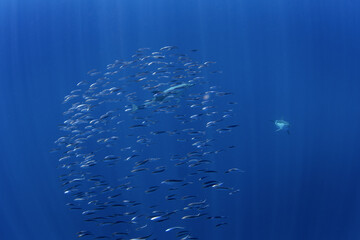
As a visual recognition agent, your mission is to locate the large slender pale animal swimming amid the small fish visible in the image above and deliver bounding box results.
[132,83,194,111]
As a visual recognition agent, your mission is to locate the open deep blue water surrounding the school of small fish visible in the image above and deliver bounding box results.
[0,0,360,240]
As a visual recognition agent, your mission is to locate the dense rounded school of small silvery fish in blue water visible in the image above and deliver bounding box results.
[54,46,243,240]
